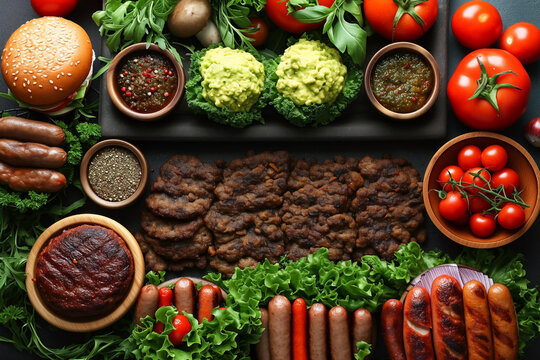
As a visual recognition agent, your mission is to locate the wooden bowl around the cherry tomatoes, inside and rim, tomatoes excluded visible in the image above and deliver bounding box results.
[423,132,540,248]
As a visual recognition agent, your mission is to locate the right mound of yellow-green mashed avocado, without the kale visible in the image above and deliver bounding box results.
[276,39,347,106]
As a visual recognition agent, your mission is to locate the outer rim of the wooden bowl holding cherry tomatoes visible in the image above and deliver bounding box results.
[422,131,540,249]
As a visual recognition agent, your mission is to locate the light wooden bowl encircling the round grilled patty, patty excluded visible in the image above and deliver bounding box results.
[26,214,145,332]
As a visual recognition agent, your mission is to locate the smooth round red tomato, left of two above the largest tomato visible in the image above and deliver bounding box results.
[452,0,502,49]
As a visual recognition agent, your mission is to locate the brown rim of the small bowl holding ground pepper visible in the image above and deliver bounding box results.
[80,139,148,209]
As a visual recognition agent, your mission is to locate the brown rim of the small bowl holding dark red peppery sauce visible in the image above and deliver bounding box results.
[107,43,186,121]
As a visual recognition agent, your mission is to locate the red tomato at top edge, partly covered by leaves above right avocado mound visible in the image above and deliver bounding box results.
[264,0,334,34]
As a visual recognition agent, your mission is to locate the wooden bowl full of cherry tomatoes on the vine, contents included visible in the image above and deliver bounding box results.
[423,132,540,248]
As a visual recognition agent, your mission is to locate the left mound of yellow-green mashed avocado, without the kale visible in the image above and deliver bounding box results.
[200,47,264,112]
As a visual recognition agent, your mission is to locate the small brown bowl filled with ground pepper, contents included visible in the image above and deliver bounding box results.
[80,139,148,209]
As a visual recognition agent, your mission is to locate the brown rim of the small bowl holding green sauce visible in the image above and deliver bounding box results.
[364,42,441,120]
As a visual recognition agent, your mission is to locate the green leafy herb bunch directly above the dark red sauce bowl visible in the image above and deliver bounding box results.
[92,0,182,64]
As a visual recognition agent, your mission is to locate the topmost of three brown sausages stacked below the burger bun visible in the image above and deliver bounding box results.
[0,116,66,146]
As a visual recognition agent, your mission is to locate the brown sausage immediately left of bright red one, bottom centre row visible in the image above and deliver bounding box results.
[268,295,291,360]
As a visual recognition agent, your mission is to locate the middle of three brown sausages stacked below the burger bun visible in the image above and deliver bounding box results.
[0,139,67,169]
